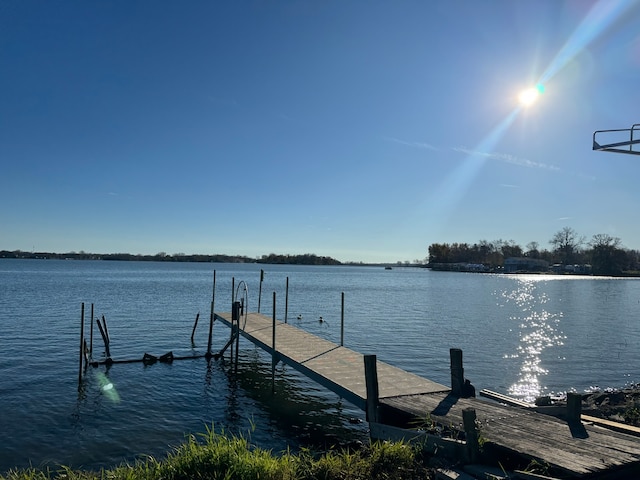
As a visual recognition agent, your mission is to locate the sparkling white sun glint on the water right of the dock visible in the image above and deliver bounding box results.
[496,277,566,402]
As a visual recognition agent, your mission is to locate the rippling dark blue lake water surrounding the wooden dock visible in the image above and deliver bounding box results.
[0,259,640,472]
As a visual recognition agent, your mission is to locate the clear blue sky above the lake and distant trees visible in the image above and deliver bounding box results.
[0,0,640,262]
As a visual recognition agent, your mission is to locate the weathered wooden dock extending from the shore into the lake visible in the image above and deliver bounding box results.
[214,313,640,478]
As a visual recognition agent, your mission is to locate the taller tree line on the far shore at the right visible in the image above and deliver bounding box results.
[428,227,640,276]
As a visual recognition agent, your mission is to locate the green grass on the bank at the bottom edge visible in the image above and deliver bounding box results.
[0,428,431,480]
